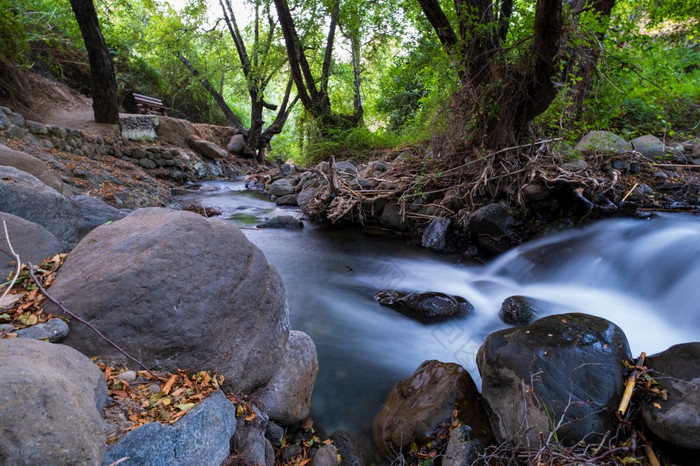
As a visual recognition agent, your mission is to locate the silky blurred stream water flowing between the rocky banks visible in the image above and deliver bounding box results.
[174,181,700,452]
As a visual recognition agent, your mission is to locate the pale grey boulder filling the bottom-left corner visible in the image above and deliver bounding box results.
[0,338,107,465]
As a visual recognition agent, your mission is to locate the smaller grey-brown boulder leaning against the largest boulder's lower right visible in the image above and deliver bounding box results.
[256,330,318,425]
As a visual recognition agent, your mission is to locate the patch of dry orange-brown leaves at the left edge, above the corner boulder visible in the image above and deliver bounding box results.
[0,254,67,337]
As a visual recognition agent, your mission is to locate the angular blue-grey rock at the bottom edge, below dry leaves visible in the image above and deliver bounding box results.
[104,391,236,466]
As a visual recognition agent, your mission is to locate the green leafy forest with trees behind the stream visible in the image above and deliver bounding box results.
[0,0,700,163]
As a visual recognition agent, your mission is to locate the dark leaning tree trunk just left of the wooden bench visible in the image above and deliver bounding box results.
[70,0,119,124]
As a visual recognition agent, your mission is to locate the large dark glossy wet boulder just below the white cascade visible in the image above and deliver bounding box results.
[477,313,631,448]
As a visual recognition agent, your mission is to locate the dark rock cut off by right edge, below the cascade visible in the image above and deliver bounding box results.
[642,342,700,450]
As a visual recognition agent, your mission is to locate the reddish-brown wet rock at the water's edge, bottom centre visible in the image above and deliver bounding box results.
[372,360,491,453]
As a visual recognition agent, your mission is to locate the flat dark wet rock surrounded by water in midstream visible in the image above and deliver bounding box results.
[374,290,474,322]
